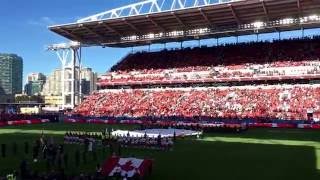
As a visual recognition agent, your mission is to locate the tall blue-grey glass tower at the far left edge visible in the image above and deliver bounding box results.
[0,54,23,102]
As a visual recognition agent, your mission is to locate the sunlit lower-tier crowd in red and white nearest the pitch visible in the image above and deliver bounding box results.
[74,85,320,120]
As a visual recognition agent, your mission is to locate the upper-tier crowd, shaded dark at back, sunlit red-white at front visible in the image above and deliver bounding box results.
[99,38,320,86]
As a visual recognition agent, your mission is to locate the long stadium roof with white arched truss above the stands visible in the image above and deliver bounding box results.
[49,0,320,47]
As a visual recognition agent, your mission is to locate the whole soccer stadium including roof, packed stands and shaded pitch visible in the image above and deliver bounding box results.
[0,0,320,180]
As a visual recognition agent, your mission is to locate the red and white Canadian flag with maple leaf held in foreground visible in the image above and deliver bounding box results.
[102,157,152,177]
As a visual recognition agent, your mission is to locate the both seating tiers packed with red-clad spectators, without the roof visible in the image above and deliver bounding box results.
[74,37,320,120]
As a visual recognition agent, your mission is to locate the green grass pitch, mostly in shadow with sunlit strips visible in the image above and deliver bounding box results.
[0,123,320,180]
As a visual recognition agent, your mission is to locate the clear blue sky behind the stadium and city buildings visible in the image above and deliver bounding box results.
[0,0,317,84]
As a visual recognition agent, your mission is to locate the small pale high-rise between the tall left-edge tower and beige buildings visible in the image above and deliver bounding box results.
[24,73,46,96]
